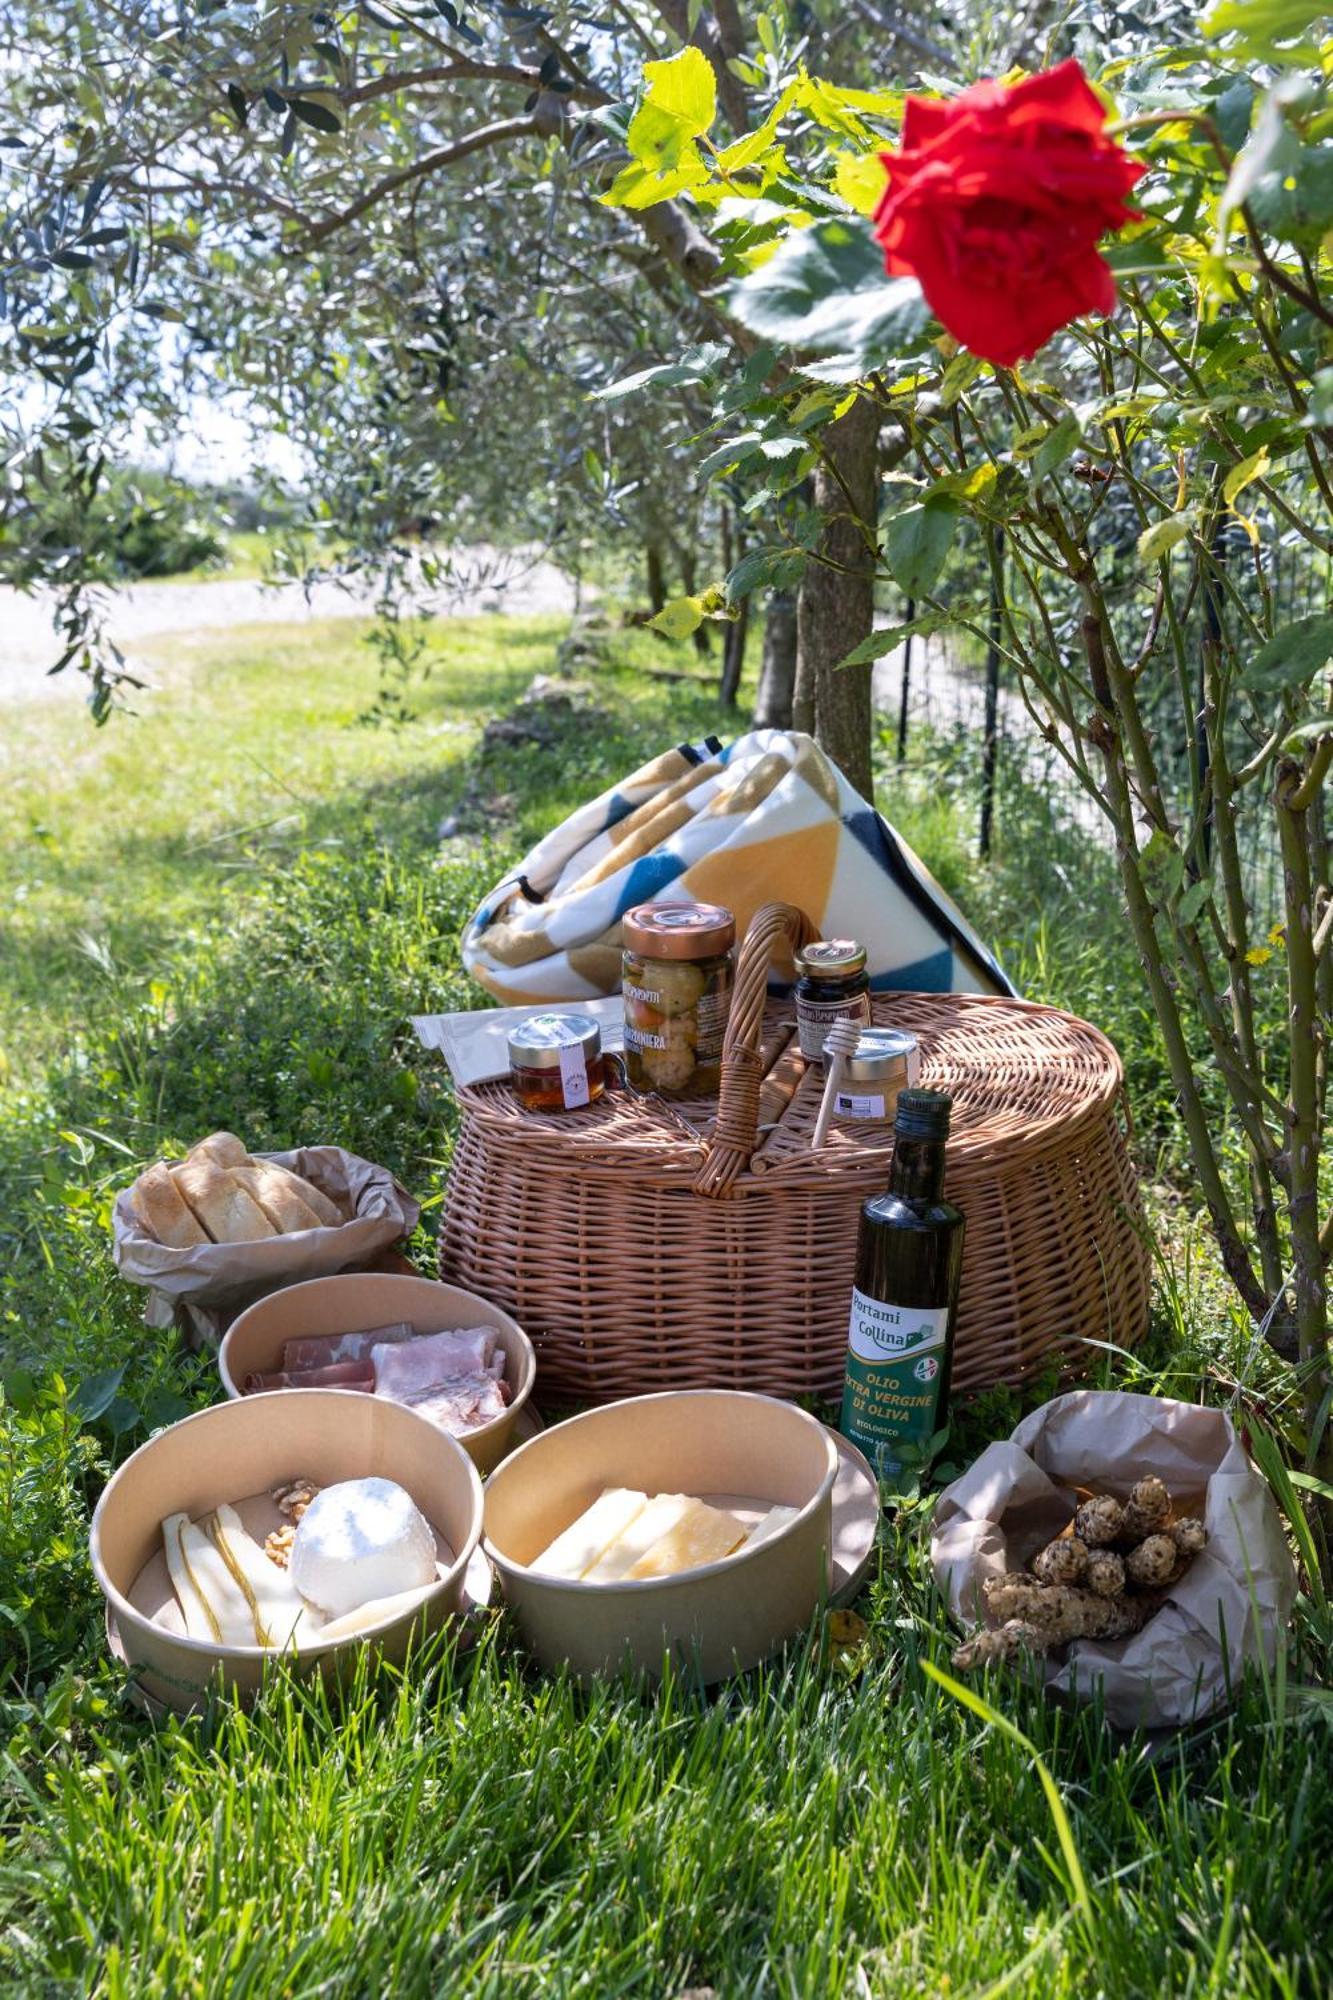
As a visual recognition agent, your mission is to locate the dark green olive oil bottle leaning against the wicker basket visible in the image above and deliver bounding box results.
[841,1090,963,1484]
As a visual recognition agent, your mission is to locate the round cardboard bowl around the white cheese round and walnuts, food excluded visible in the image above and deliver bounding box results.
[90,1388,482,1712]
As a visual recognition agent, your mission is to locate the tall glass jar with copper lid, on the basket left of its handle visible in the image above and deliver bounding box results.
[620,902,737,1098]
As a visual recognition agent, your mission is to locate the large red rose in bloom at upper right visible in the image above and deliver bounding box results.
[875,62,1143,368]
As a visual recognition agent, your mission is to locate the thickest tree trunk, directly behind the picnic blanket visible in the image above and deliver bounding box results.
[795,396,879,798]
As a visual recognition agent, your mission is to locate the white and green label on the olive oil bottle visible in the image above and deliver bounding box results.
[839,1292,949,1480]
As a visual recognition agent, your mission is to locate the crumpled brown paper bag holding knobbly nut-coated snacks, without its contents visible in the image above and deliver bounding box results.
[931,1390,1295,1730]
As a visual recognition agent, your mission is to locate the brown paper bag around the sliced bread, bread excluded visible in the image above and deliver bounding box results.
[112,1146,420,1348]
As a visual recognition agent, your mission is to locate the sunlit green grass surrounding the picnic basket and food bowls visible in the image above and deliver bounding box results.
[0,620,1333,2000]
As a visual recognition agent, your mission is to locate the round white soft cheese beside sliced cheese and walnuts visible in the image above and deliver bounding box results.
[288,1480,436,1618]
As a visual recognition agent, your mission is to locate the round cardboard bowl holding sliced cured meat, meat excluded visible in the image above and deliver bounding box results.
[218,1274,536,1474]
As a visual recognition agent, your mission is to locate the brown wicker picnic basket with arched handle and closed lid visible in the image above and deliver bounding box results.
[440,904,1149,1402]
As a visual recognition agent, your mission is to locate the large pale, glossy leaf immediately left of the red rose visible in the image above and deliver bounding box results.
[729,222,931,382]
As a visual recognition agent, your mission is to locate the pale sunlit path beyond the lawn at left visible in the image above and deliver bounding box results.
[0,550,574,704]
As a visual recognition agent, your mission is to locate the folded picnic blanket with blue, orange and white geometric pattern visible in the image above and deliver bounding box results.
[462,730,1013,1006]
